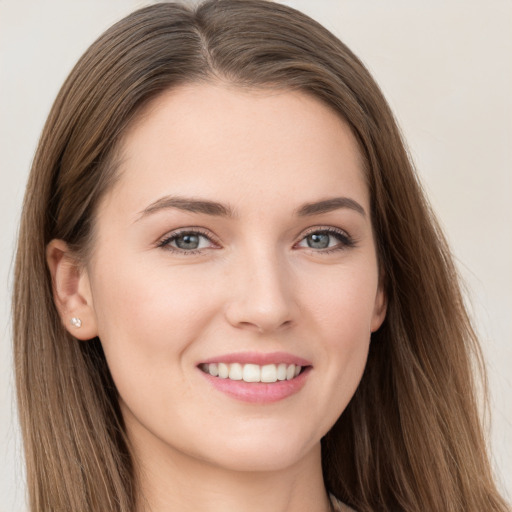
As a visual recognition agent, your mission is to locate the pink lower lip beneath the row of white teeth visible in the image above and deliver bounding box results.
[199,367,311,404]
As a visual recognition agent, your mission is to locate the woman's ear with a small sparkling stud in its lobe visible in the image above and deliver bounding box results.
[46,240,98,340]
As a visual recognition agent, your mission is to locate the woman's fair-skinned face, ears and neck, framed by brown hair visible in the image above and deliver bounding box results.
[47,84,385,512]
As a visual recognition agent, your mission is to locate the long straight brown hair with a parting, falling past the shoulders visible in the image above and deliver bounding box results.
[13,0,507,512]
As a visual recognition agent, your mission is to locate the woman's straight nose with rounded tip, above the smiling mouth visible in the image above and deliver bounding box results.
[225,249,298,334]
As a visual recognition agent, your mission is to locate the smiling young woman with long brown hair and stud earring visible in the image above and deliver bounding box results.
[14,0,506,511]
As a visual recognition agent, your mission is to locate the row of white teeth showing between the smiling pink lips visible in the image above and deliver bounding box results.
[199,363,308,383]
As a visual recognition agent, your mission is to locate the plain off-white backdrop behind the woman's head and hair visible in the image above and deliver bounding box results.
[0,0,512,512]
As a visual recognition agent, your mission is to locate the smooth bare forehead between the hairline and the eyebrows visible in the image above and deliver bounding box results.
[105,83,368,218]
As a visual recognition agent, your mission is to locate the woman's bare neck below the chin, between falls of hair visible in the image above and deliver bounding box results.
[137,434,330,512]
